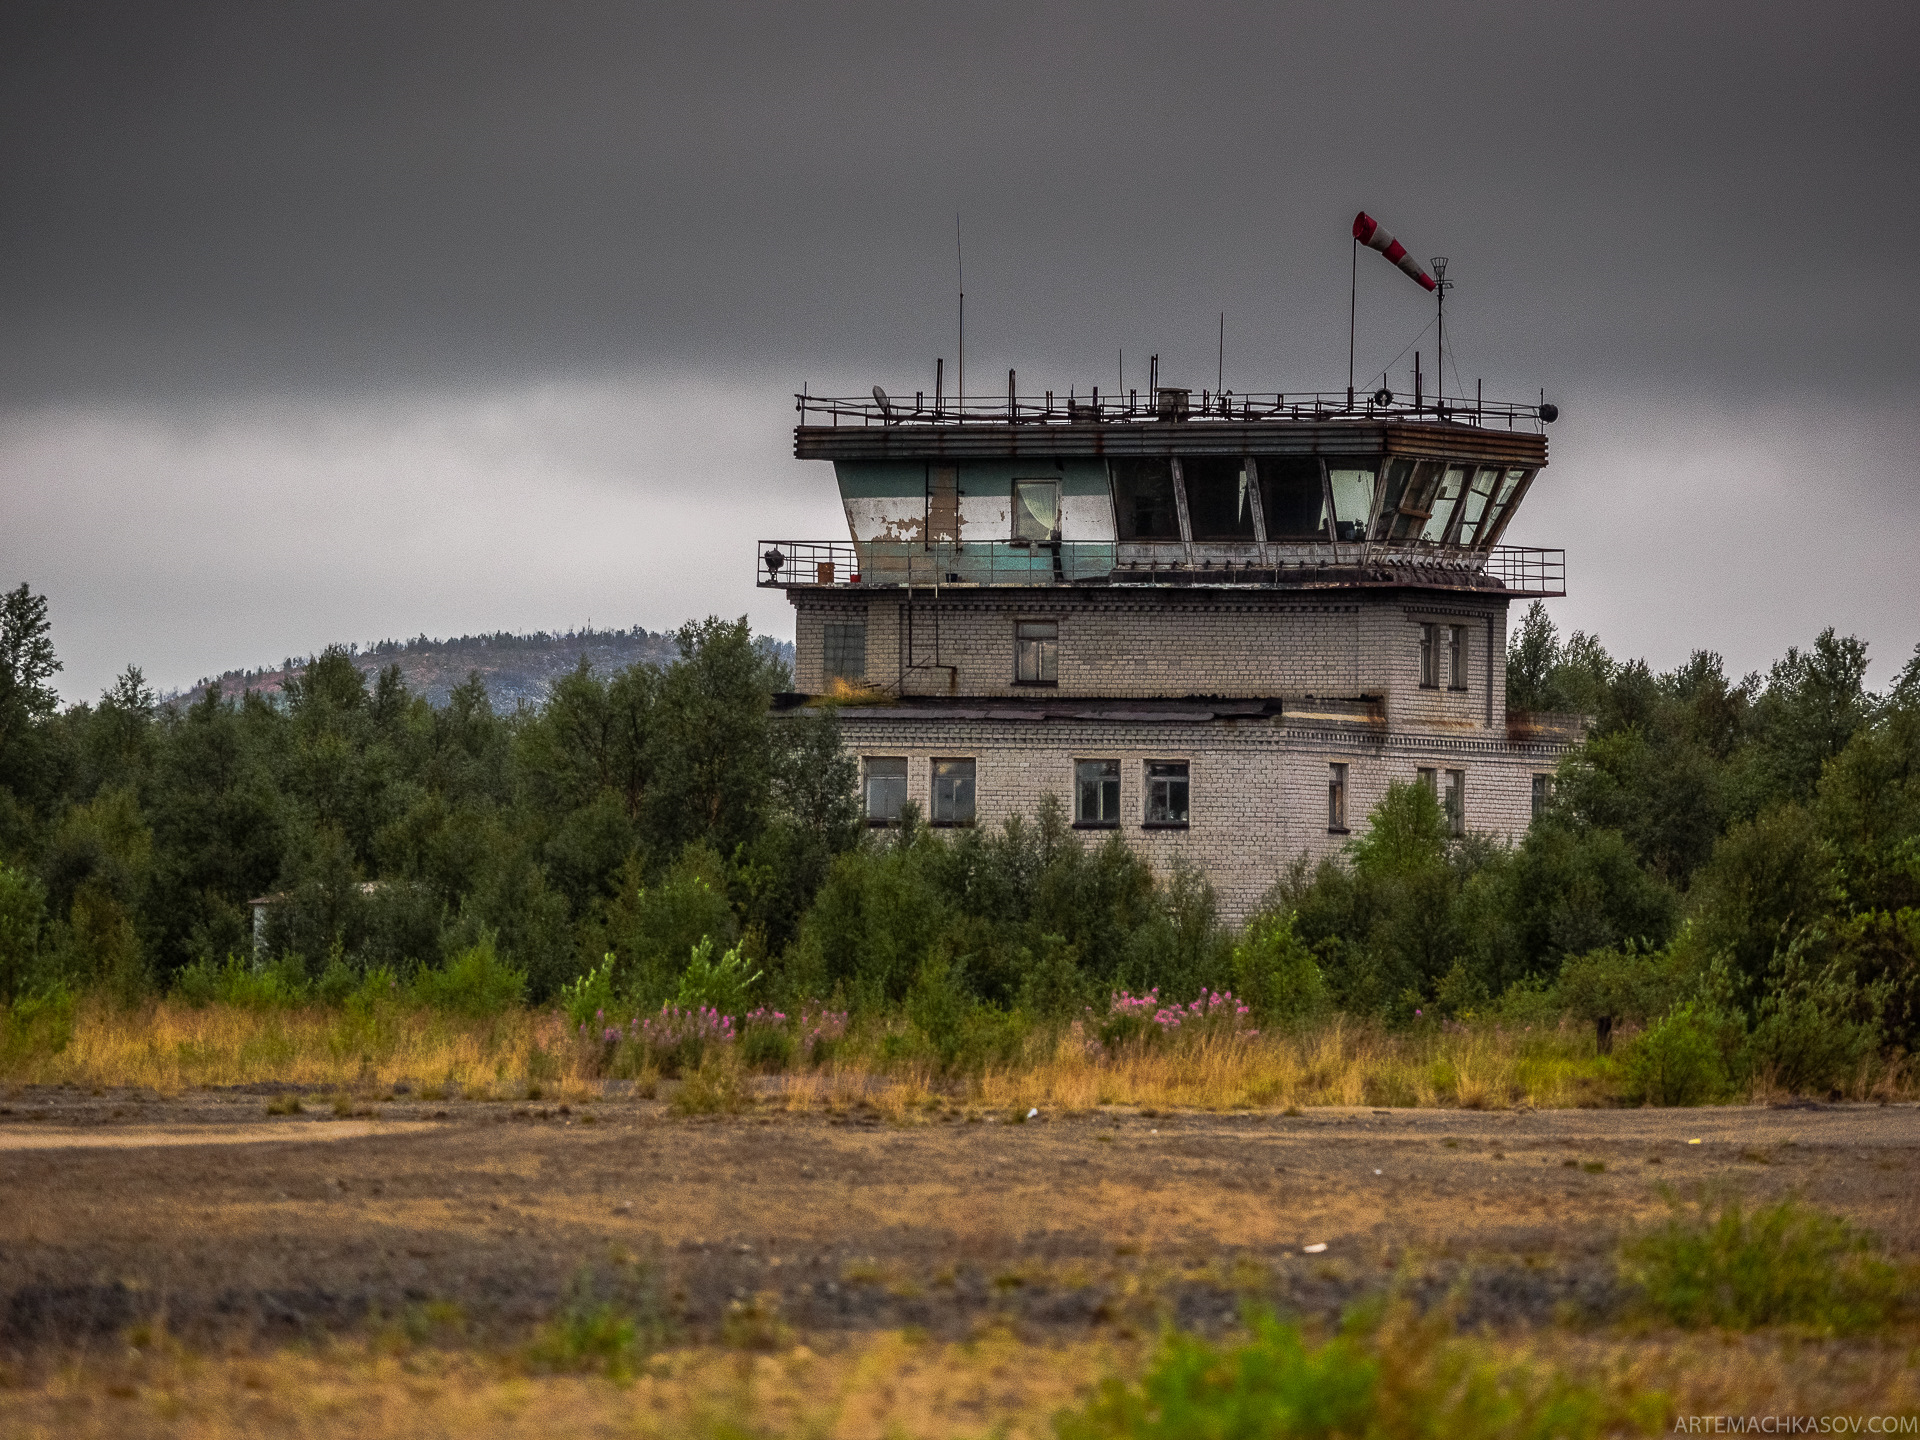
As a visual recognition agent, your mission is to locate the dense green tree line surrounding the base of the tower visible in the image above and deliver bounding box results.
[0,586,1920,1090]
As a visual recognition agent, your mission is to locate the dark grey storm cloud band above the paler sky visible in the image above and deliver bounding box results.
[0,2,1920,401]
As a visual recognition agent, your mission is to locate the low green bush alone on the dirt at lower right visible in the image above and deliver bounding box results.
[1622,1200,1901,1334]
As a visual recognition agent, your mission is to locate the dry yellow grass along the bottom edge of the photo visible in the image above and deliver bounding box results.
[0,1329,1920,1440]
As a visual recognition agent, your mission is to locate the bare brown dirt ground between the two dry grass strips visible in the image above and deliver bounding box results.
[0,1089,1920,1359]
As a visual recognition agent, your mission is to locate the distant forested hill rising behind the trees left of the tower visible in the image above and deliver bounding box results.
[167,626,793,710]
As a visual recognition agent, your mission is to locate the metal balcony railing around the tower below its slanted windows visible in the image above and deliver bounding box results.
[758,540,1567,597]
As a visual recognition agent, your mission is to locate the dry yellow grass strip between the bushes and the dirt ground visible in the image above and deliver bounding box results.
[0,1000,1916,1119]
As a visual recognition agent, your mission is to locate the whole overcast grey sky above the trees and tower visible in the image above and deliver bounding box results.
[0,0,1920,699]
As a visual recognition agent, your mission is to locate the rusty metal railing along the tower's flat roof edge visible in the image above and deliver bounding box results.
[793,386,1559,430]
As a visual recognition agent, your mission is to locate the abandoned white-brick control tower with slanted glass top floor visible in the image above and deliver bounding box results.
[758,360,1571,922]
